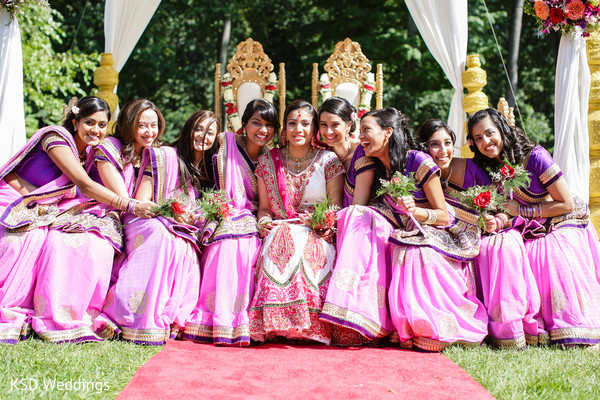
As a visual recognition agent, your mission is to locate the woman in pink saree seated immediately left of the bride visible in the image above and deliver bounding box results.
[183,99,279,346]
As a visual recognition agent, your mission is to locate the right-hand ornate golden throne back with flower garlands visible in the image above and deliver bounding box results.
[312,38,383,117]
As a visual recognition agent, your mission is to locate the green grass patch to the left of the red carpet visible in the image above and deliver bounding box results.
[0,339,162,399]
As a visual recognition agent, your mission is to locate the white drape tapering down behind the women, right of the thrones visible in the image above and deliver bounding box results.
[405,0,468,156]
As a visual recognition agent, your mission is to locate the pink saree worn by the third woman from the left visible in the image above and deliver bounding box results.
[100,146,200,345]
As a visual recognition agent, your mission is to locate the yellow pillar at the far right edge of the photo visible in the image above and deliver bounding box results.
[586,32,600,238]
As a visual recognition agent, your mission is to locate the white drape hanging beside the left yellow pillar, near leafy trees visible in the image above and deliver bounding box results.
[104,0,160,72]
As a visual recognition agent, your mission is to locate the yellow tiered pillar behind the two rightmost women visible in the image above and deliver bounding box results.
[461,54,488,157]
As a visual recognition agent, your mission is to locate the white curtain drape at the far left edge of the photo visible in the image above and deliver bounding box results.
[0,8,26,166]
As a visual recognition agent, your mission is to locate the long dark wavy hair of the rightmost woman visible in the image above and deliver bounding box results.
[467,108,535,169]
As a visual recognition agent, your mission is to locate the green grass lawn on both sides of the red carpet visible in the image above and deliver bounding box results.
[0,339,600,400]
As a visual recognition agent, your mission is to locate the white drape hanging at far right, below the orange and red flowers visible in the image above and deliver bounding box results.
[554,33,591,203]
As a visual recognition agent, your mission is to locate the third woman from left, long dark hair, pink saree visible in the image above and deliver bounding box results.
[98,111,219,345]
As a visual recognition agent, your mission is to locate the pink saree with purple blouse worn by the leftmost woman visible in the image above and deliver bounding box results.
[0,126,78,344]
